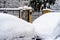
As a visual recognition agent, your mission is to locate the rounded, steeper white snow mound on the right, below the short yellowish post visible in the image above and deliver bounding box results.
[33,12,60,40]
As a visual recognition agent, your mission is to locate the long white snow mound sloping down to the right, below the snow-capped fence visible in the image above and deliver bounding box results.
[0,13,34,40]
